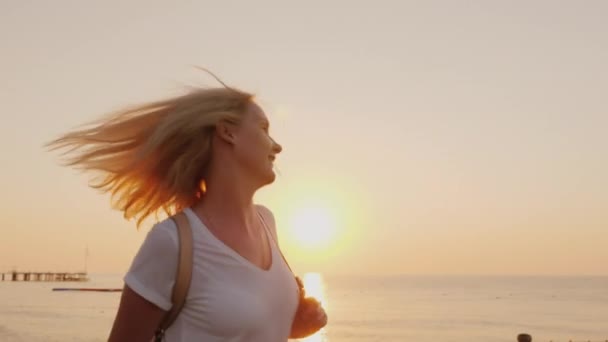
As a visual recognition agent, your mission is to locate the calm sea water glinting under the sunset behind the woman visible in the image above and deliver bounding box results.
[0,274,608,342]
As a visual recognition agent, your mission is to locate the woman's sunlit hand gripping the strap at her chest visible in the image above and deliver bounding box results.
[289,297,327,338]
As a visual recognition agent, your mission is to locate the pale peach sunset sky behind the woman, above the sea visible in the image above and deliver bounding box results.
[0,0,608,275]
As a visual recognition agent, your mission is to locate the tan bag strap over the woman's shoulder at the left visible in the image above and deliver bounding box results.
[154,212,193,341]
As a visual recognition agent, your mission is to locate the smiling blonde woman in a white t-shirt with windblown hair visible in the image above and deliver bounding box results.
[49,73,327,342]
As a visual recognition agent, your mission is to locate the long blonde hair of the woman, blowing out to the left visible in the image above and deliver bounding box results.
[46,83,253,227]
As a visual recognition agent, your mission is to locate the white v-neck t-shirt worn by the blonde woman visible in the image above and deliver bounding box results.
[124,208,298,342]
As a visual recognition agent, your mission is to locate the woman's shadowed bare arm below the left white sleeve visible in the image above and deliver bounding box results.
[108,285,166,342]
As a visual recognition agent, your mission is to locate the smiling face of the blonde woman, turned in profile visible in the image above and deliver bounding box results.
[234,102,282,185]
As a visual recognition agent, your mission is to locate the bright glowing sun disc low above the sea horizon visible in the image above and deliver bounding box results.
[289,207,337,248]
